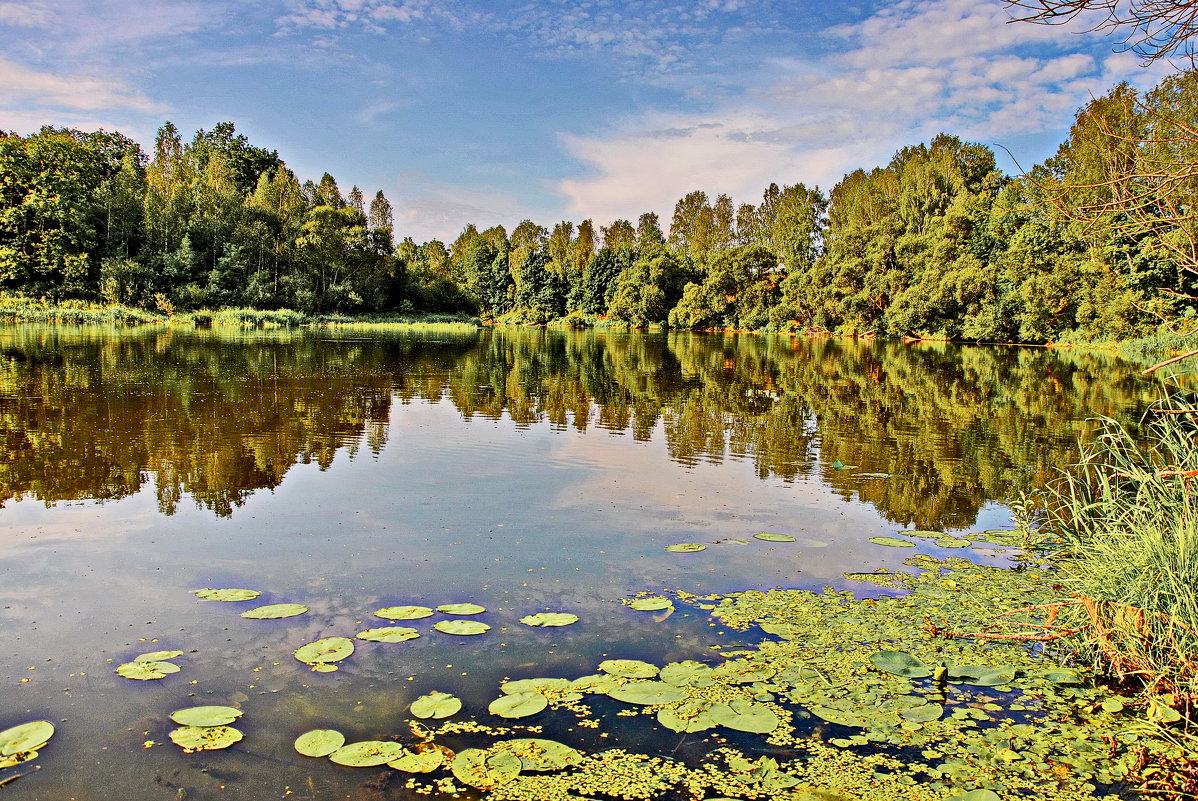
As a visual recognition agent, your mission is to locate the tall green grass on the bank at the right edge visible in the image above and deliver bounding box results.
[1048,393,1198,704]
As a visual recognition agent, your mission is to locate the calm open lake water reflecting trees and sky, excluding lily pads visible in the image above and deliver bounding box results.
[0,327,1154,801]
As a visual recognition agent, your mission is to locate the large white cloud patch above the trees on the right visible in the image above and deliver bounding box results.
[557,0,1155,227]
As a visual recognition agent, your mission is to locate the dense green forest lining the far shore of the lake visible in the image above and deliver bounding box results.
[0,71,1198,342]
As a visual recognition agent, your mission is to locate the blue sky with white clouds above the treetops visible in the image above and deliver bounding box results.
[0,0,1168,241]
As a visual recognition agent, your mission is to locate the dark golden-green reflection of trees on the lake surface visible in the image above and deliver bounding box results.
[0,328,1149,527]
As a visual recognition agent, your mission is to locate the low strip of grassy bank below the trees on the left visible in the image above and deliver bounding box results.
[0,296,478,332]
